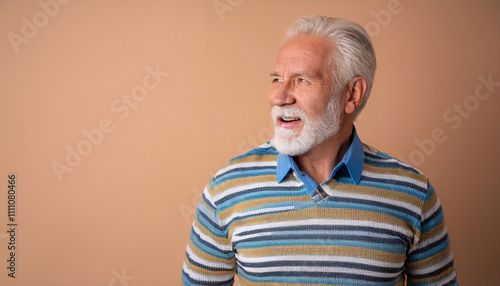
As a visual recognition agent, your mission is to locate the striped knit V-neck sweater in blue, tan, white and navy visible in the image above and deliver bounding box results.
[182,143,458,286]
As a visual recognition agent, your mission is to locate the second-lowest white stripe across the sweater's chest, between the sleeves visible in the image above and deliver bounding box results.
[233,219,414,241]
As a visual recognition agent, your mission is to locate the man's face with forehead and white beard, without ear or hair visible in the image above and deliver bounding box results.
[269,36,343,156]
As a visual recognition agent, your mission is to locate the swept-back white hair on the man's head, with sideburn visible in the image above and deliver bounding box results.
[285,15,377,119]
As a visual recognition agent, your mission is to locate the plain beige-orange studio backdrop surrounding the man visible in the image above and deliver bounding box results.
[0,0,500,286]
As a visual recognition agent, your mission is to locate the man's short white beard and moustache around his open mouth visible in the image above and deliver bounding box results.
[271,95,343,156]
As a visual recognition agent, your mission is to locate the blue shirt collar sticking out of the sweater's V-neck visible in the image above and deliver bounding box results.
[276,127,365,185]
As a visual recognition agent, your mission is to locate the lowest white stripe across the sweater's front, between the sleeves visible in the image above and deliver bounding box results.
[236,254,404,268]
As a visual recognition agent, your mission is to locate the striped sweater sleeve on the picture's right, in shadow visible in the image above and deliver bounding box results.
[405,182,458,286]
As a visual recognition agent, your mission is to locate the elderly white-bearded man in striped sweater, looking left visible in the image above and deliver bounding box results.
[182,16,458,285]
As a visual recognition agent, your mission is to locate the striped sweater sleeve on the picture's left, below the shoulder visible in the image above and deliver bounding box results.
[182,181,236,286]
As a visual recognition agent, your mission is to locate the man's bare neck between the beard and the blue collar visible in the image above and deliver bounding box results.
[293,123,353,184]
